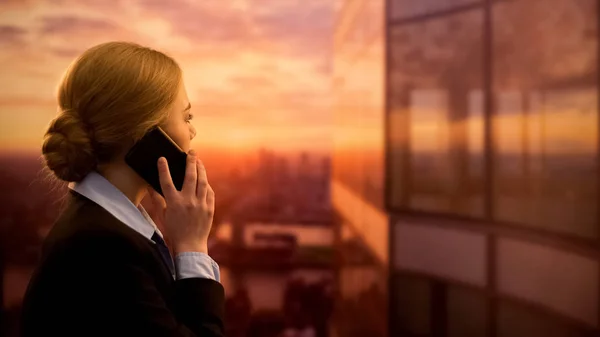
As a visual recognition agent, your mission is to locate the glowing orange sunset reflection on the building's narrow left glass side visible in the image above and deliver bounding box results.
[334,0,385,209]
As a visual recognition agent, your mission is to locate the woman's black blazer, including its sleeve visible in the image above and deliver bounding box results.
[21,191,225,337]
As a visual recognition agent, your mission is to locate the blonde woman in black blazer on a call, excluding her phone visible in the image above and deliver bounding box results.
[22,42,224,337]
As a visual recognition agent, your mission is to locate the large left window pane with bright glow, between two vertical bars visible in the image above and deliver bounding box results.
[389,9,483,217]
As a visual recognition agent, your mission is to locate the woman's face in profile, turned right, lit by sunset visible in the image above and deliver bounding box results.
[162,83,196,152]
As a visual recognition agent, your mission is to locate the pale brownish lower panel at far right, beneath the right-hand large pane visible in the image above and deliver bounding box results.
[497,238,599,325]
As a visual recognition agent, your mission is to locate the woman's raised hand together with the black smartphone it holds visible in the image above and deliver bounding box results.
[125,127,215,254]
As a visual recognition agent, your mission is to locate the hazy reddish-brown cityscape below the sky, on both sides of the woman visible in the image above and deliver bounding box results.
[0,149,333,337]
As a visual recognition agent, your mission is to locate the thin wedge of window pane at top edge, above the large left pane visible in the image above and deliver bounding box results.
[389,0,482,19]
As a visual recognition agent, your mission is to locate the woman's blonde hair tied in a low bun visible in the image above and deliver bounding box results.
[42,42,182,182]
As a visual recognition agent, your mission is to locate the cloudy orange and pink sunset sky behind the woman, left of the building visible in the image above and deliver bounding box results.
[0,0,337,150]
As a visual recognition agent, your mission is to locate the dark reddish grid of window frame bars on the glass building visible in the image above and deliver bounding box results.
[384,0,600,336]
